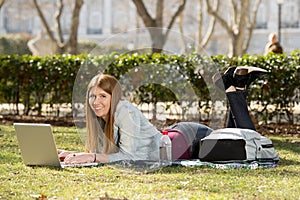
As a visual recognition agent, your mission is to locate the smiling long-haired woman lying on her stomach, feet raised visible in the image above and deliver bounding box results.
[58,67,266,164]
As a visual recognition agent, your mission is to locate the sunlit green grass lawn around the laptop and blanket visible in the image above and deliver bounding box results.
[0,125,300,200]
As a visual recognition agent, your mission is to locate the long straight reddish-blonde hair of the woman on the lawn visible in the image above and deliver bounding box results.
[85,74,122,154]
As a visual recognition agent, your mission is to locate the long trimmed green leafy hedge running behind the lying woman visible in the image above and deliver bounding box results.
[0,51,300,123]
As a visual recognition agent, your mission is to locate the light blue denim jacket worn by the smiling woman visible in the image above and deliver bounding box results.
[109,100,161,162]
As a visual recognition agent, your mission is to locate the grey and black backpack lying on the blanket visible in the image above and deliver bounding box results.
[199,128,279,163]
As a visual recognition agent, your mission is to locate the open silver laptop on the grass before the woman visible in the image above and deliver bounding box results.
[14,123,98,168]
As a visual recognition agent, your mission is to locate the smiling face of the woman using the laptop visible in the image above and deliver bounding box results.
[89,87,111,121]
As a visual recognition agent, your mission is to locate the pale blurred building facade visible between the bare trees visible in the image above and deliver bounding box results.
[0,0,300,54]
